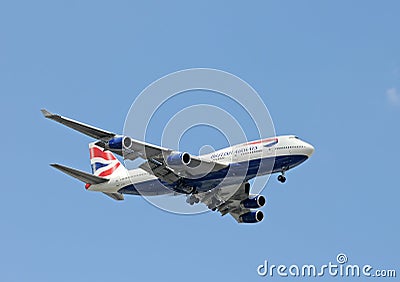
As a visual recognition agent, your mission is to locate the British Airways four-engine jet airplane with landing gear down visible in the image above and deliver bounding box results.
[41,109,314,223]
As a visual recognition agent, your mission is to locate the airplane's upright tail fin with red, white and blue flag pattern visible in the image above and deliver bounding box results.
[89,142,126,177]
